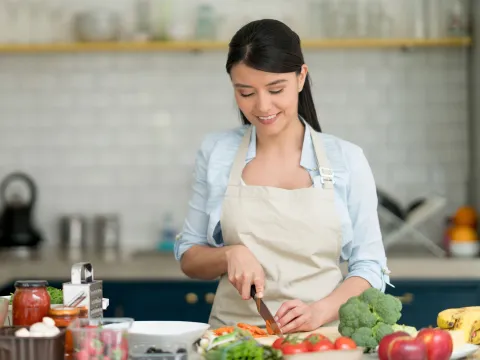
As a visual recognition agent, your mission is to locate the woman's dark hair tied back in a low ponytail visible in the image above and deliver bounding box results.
[226,19,322,132]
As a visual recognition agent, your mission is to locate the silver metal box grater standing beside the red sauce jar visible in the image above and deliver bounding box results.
[63,262,103,319]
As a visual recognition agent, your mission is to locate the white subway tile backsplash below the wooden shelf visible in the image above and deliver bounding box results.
[0,45,468,246]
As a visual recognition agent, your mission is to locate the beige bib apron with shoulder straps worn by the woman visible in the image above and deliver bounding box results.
[209,124,343,328]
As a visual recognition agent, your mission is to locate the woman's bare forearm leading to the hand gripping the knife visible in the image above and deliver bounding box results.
[180,245,230,280]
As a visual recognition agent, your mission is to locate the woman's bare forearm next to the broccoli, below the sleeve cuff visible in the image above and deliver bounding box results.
[317,276,371,324]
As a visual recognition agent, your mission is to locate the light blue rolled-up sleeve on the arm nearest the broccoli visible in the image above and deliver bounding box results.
[346,148,390,291]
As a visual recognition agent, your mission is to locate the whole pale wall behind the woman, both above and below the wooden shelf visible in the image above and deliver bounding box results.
[0,0,479,253]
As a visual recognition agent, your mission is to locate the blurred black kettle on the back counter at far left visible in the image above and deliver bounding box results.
[0,172,43,248]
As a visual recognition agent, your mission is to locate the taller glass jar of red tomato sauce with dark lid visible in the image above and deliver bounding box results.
[12,280,50,326]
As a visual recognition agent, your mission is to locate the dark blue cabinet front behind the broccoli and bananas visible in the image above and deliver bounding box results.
[386,280,480,329]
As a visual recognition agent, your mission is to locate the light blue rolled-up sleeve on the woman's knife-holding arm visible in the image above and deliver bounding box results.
[174,136,215,261]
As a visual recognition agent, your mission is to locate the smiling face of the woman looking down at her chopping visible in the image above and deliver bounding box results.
[230,63,307,135]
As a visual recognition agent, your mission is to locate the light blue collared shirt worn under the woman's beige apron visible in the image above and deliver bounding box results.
[175,125,390,291]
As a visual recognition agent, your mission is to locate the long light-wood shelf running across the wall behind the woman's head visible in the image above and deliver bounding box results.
[0,37,472,54]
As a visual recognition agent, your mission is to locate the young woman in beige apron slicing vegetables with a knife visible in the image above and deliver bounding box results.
[175,20,389,333]
